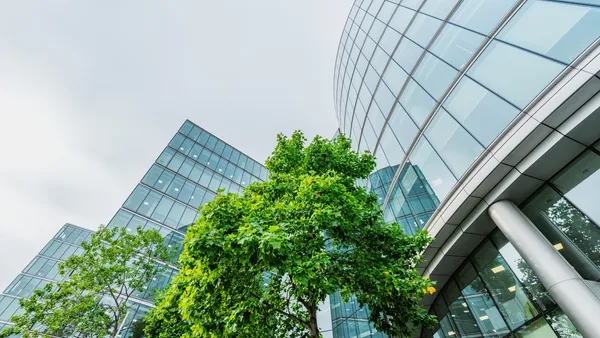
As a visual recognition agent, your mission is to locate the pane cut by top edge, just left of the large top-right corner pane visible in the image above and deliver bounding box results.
[450,0,517,35]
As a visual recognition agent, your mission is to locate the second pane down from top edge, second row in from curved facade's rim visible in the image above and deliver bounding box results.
[430,25,484,69]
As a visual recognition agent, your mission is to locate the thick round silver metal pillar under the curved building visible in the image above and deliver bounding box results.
[488,201,600,338]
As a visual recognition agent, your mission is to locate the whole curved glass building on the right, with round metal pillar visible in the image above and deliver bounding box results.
[332,0,600,337]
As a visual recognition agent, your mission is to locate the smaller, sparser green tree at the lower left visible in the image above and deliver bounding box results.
[0,226,171,338]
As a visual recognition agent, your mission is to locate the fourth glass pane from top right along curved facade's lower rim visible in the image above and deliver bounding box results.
[425,108,483,177]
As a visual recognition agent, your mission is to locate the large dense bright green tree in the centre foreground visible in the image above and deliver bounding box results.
[146,132,435,338]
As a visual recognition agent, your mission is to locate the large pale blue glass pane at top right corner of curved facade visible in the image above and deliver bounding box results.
[498,0,600,63]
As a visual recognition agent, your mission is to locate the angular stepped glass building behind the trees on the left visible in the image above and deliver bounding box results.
[0,121,268,337]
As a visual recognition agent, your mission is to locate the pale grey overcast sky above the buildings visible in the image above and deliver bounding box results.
[0,0,352,290]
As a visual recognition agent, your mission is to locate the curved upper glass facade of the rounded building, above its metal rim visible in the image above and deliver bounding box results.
[334,0,600,219]
